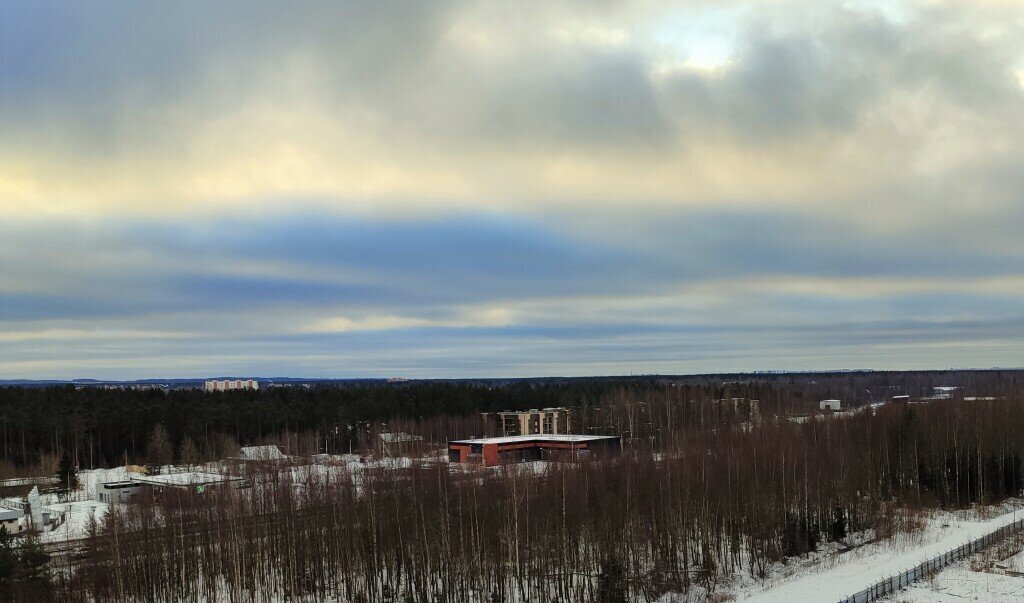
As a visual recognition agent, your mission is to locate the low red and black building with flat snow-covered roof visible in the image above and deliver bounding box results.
[449,434,623,467]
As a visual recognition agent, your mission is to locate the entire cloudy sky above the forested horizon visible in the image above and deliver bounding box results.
[0,0,1024,379]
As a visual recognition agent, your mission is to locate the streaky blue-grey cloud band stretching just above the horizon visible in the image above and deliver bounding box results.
[0,211,1024,376]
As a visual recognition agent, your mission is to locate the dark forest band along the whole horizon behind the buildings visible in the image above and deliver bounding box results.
[0,371,1024,476]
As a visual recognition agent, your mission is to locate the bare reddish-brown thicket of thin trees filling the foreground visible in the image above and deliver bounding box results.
[29,389,1024,602]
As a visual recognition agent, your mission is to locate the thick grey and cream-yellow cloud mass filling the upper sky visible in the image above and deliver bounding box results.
[0,2,1024,215]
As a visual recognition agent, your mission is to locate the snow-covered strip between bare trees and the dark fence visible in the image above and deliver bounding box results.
[732,502,1024,603]
